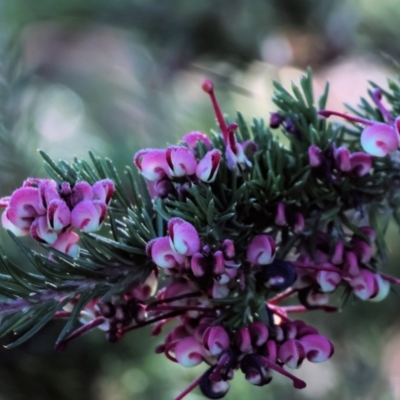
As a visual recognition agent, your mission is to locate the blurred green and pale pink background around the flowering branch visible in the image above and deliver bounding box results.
[0,0,400,400]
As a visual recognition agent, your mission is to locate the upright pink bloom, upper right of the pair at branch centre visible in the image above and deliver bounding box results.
[168,218,201,256]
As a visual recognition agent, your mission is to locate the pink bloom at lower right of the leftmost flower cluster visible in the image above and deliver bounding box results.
[71,200,107,232]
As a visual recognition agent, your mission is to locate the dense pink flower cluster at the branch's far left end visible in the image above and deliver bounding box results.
[0,178,114,257]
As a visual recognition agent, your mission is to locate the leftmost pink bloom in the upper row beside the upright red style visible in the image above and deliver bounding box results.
[133,149,169,181]
